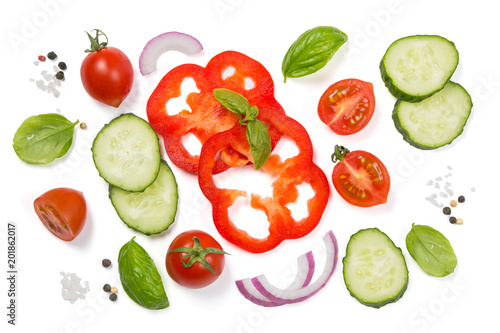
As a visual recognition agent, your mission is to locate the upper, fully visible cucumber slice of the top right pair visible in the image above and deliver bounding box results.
[380,35,458,102]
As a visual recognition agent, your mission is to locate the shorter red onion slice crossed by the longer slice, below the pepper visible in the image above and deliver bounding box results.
[236,251,315,307]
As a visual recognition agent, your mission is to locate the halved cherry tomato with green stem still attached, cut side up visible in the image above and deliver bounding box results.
[332,146,391,207]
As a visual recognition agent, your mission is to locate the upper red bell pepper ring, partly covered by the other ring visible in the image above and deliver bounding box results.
[147,51,285,173]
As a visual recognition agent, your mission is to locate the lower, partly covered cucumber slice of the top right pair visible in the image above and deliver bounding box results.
[392,81,472,149]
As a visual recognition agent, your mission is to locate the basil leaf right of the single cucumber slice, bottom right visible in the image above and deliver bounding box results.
[406,224,457,277]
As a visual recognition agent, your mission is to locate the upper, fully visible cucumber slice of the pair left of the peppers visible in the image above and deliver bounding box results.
[92,113,161,191]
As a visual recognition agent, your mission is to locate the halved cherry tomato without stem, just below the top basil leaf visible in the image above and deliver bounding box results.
[318,79,375,135]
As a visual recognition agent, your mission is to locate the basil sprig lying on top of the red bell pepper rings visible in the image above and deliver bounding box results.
[213,88,272,170]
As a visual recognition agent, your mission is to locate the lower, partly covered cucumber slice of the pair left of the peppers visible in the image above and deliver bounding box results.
[109,161,178,235]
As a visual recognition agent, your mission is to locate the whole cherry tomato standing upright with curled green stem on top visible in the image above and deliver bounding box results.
[80,30,134,107]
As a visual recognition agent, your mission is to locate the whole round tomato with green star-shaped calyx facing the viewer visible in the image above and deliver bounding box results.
[165,230,228,289]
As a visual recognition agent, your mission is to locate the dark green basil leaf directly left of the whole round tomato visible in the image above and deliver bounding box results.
[118,237,169,310]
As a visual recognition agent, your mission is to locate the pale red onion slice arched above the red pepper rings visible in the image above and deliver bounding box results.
[139,31,203,75]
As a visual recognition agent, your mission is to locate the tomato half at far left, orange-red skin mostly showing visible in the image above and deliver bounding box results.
[34,187,87,241]
